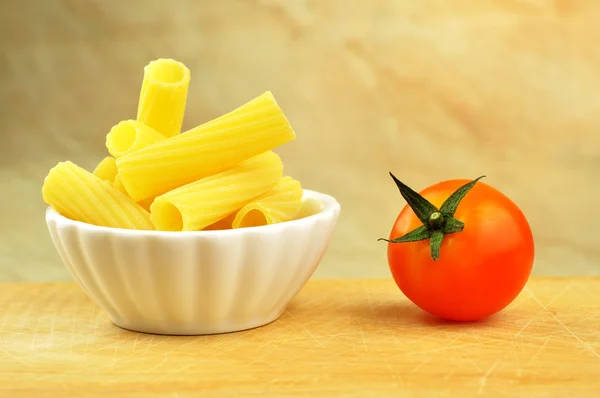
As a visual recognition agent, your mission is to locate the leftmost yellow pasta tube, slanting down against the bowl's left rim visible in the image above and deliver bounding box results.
[42,162,153,230]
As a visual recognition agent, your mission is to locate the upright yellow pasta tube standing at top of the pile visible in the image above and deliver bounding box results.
[137,58,190,137]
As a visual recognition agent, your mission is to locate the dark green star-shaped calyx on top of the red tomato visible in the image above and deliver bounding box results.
[378,172,485,261]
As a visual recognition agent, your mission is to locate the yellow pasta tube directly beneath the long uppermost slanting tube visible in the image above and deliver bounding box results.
[150,151,283,231]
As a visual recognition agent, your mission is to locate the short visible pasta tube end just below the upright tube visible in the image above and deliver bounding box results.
[106,120,167,159]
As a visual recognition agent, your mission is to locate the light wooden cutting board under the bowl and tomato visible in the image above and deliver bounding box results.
[0,278,600,398]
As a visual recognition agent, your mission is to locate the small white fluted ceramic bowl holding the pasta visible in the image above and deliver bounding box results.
[46,190,340,335]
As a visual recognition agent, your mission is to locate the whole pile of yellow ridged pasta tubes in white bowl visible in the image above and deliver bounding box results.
[42,58,303,231]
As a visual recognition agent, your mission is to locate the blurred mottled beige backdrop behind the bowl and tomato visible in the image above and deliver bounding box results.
[0,0,600,280]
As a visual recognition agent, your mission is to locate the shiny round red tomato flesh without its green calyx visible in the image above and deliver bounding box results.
[388,180,534,321]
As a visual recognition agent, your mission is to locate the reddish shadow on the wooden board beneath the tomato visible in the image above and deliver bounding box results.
[347,301,498,330]
